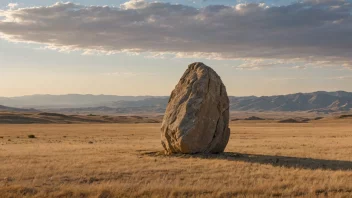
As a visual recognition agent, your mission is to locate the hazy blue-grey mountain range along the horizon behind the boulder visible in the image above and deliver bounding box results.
[0,91,352,114]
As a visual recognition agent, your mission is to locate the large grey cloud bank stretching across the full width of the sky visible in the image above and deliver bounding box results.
[0,0,352,68]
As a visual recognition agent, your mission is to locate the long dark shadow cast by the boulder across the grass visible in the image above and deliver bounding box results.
[142,152,352,171]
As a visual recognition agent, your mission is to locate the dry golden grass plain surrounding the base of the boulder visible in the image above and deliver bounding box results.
[0,119,352,198]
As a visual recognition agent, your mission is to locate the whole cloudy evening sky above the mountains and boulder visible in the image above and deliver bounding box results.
[0,0,352,97]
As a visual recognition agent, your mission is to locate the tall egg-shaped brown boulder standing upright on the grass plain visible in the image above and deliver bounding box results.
[161,63,230,153]
